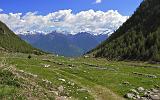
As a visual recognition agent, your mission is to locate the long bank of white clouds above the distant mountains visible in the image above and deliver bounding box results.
[0,9,128,34]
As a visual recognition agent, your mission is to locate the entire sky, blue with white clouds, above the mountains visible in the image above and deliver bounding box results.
[0,0,143,34]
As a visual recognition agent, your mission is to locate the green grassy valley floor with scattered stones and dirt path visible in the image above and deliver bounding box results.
[0,53,160,100]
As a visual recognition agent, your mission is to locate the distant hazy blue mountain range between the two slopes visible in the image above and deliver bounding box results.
[19,32,108,56]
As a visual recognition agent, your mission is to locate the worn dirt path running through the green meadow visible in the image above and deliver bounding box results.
[57,70,124,100]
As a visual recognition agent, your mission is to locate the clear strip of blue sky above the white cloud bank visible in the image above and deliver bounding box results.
[0,0,142,16]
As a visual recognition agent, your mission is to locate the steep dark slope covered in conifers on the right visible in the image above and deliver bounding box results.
[88,0,160,61]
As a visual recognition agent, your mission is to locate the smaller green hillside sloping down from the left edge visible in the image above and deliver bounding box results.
[0,21,41,53]
